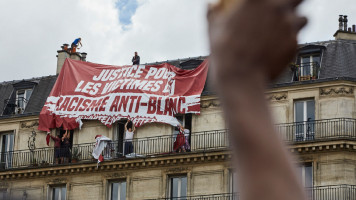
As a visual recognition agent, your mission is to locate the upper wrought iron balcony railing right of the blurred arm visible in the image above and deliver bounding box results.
[276,118,356,142]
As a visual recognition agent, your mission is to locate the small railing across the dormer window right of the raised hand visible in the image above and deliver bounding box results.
[291,62,320,81]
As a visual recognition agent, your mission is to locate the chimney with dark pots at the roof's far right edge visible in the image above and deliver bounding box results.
[334,15,356,41]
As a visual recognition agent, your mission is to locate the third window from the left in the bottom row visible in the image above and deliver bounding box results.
[169,176,187,199]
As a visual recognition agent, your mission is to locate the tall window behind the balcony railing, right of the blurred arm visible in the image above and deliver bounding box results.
[294,100,315,141]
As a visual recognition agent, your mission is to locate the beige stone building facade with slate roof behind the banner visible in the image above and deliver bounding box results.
[0,16,356,200]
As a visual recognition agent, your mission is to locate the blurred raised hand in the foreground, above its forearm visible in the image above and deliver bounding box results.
[208,0,306,84]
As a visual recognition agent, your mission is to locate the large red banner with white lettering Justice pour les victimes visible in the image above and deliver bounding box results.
[38,59,208,131]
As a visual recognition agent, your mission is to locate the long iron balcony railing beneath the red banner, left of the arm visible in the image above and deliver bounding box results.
[0,129,228,170]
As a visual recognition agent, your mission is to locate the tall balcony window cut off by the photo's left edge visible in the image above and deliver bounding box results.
[0,131,14,169]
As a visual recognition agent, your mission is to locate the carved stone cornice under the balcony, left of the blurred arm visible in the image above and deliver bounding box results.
[0,150,231,182]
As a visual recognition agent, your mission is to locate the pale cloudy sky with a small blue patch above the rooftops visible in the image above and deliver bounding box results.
[0,0,356,81]
